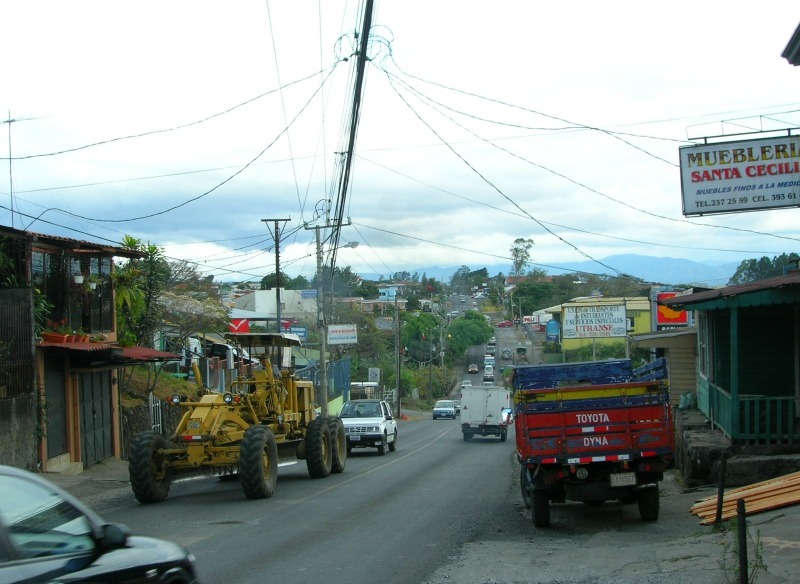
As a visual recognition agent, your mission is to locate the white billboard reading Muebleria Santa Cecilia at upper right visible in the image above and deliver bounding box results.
[680,136,800,216]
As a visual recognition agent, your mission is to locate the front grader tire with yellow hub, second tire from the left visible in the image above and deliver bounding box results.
[239,426,278,499]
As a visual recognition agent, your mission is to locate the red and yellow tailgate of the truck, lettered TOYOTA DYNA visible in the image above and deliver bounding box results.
[515,382,673,464]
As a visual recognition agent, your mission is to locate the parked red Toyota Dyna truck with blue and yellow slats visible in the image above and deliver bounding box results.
[511,359,674,527]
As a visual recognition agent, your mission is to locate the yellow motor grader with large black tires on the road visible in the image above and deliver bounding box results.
[128,333,347,503]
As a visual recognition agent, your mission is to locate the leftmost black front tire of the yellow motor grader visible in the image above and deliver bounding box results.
[128,432,172,503]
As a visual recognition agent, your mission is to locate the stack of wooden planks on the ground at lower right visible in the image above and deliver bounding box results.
[690,472,800,525]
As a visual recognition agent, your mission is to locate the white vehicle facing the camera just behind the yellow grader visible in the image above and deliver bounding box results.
[339,399,397,456]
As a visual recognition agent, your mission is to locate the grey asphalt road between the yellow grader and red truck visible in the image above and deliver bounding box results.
[101,414,513,584]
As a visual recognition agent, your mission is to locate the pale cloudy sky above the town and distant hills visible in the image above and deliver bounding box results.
[0,0,800,285]
